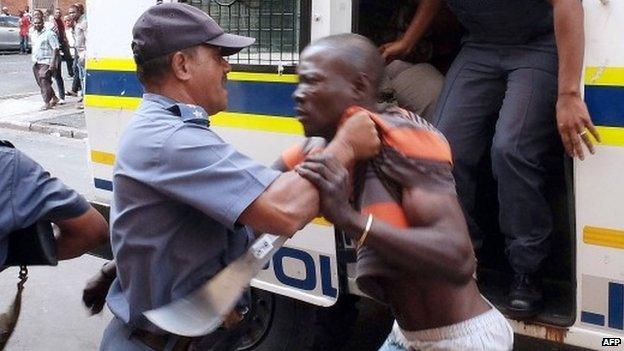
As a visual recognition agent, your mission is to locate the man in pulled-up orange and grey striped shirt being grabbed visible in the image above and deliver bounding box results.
[294,34,513,351]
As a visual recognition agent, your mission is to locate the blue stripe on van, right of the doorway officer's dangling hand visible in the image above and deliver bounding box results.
[585,85,624,127]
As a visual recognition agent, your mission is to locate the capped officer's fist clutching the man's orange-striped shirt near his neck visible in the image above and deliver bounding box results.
[335,111,381,160]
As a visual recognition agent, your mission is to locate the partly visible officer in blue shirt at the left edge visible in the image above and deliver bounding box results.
[0,141,108,267]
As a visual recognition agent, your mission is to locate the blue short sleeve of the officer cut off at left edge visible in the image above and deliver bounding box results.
[11,150,89,229]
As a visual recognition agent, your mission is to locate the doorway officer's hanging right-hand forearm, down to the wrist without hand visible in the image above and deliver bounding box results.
[550,0,585,96]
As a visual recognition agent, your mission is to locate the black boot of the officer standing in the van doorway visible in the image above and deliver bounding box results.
[506,273,542,319]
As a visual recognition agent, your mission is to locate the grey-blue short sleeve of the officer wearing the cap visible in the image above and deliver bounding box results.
[154,124,281,228]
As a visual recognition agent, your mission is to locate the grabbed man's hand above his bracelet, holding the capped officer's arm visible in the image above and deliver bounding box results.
[295,155,358,227]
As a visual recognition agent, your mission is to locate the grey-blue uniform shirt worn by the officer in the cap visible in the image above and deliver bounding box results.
[107,94,280,332]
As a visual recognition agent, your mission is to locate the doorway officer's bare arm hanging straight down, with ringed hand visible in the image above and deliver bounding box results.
[549,0,600,160]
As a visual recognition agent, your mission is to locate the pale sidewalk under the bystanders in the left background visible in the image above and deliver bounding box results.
[0,92,87,139]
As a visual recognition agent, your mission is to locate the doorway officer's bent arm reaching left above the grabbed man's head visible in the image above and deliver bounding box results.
[379,0,442,61]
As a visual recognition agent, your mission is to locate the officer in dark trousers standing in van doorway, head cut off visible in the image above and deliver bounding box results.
[381,0,600,317]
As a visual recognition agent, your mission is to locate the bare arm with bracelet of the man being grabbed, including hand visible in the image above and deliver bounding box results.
[297,156,476,284]
